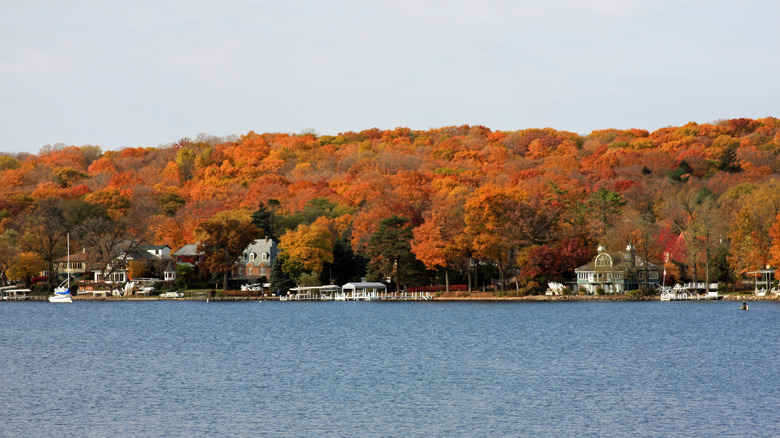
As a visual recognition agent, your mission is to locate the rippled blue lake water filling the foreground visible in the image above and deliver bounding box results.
[0,301,780,437]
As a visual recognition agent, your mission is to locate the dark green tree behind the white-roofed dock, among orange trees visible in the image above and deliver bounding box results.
[368,216,414,293]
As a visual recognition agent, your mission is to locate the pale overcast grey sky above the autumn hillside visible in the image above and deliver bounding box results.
[0,0,780,153]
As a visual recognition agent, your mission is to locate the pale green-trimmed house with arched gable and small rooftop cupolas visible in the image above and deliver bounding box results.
[574,245,661,294]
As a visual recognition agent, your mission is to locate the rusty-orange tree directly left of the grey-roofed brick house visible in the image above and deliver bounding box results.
[195,214,259,290]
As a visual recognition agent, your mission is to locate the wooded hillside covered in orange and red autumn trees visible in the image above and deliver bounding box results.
[0,118,780,293]
